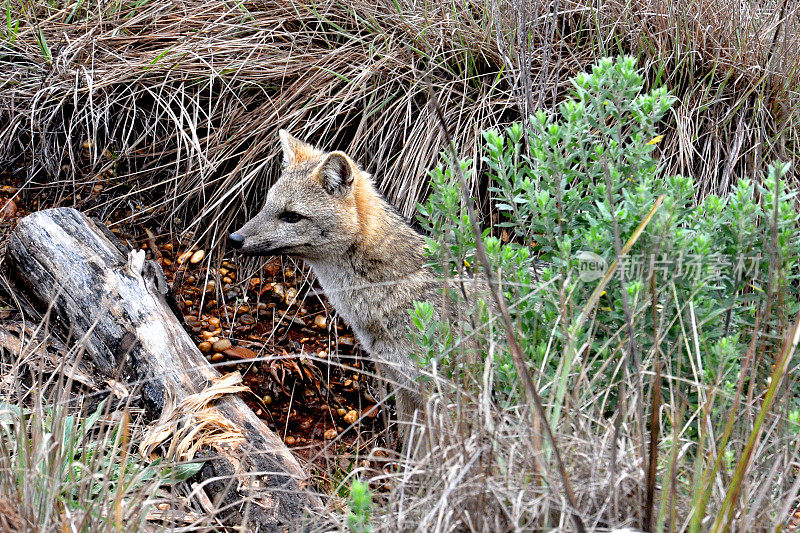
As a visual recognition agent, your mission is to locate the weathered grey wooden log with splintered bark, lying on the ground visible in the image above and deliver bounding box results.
[8,208,321,531]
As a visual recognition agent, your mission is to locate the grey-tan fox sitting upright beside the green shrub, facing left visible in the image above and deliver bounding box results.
[228,130,441,438]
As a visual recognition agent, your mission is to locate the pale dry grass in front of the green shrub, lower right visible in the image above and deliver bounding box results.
[318,306,800,532]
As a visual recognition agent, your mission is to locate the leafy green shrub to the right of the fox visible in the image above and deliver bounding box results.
[412,57,800,424]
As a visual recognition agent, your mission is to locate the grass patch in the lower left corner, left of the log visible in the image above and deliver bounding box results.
[0,324,209,532]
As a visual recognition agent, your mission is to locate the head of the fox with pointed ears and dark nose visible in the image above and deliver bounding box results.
[229,130,378,260]
